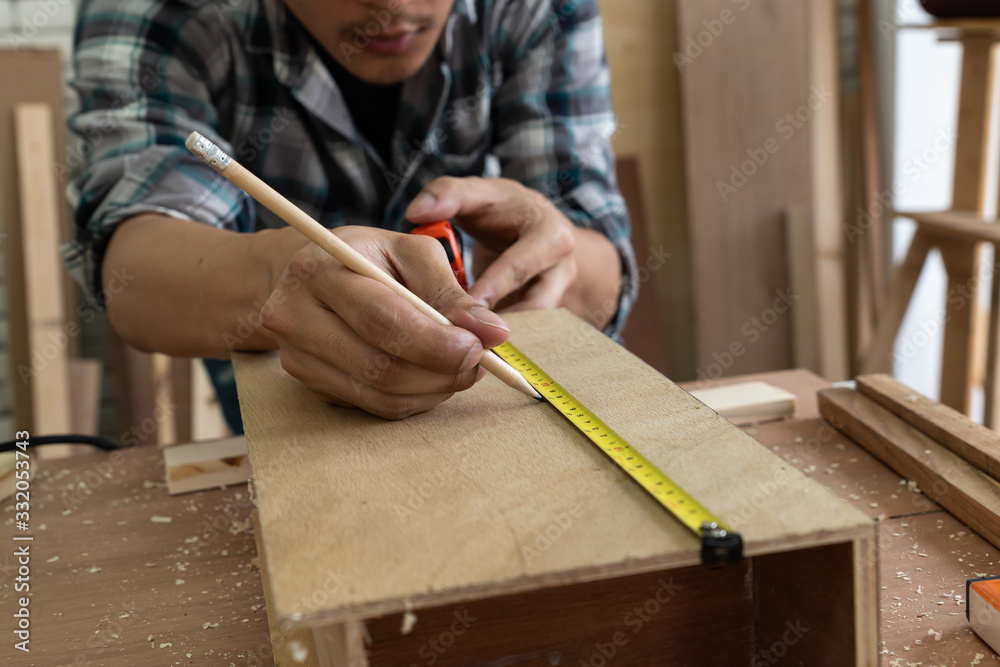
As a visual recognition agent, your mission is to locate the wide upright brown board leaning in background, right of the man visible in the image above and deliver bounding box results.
[678,0,812,378]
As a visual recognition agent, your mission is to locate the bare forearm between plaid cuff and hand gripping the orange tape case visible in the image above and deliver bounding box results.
[562,227,622,329]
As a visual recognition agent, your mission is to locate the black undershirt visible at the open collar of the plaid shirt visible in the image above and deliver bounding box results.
[310,35,403,168]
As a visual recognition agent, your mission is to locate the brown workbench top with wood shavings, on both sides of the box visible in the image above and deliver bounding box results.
[0,370,1000,667]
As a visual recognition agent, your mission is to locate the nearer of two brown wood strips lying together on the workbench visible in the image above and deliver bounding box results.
[819,389,1000,546]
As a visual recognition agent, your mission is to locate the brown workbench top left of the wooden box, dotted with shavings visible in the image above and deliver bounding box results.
[0,446,272,667]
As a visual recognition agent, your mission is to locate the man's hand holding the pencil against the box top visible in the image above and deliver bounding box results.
[262,227,510,419]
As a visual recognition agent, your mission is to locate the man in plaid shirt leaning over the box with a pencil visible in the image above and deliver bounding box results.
[64,0,636,418]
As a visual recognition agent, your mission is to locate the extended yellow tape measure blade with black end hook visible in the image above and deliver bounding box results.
[493,342,743,565]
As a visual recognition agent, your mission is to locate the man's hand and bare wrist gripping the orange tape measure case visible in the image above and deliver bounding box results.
[406,177,621,327]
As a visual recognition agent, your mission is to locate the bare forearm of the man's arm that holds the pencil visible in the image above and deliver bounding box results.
[102,215,306,358]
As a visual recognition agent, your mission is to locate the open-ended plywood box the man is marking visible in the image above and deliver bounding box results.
[236,311,877,667]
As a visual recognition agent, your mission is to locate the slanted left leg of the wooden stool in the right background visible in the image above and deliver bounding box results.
[861,229,934,373]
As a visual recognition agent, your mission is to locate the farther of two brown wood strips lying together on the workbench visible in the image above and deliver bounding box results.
[858,374,1000,480]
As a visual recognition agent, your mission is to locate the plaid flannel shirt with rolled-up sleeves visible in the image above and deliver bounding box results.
[62,0,638,336]
